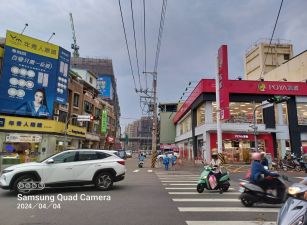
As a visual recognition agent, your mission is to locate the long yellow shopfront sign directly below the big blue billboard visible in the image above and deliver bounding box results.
[0,116,86,137]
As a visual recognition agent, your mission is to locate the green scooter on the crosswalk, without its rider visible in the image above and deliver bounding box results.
[197,166,230,193]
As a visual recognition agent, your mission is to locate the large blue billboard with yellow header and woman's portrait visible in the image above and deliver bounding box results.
[0,31,70,117]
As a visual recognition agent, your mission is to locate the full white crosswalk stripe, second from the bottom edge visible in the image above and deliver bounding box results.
[178,207,280,213]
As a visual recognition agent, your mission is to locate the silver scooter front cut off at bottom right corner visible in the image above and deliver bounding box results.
[277,184,307,225]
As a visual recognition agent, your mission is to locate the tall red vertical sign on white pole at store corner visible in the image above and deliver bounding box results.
[218,45,230,120]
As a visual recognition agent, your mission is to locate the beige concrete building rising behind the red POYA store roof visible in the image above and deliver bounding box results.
[244,40,293,80]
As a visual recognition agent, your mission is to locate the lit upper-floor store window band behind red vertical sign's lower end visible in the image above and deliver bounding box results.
[212,102,263,124]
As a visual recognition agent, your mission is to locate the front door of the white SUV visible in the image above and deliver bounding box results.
[43,151,78,184]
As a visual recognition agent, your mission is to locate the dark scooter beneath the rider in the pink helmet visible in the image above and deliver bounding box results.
[239,175,288,207]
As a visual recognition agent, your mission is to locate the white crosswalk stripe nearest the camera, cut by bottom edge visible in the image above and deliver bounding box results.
[185,221,277,225]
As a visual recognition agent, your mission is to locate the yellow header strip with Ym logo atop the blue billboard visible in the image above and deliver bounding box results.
[5,30,59,59]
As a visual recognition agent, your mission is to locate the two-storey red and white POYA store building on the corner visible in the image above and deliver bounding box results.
[173,80,307,162]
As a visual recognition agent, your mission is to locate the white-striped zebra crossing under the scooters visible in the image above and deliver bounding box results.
[155,171,280,225]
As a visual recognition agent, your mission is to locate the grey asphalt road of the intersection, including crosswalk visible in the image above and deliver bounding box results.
[0,156,304,225]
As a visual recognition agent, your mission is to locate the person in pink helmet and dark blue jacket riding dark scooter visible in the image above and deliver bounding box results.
[250,152,280,195]
